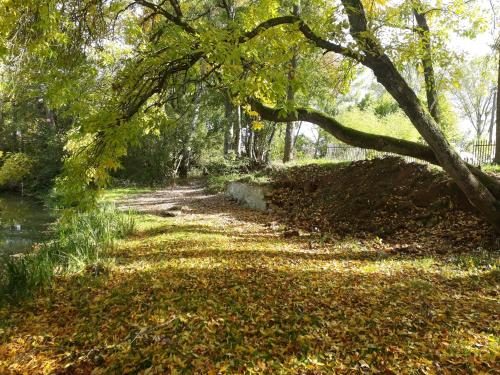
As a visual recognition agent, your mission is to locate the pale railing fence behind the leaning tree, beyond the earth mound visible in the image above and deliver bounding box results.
[327,141,495,165]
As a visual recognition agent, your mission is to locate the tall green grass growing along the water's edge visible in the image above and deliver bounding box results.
[0,205,135,302]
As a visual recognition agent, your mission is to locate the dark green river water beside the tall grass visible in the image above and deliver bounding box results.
[0,193,54,255]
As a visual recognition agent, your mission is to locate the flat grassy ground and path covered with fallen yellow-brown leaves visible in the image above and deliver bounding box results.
[0,188,500,374]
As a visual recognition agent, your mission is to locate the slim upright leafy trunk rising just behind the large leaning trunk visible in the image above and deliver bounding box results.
[413,3,441,124]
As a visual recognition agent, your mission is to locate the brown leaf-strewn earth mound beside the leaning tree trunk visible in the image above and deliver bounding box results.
[270,157,497,252]
